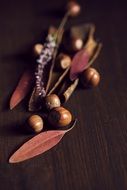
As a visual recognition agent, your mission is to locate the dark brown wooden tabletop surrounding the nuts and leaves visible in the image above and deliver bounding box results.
[0,0,127,190]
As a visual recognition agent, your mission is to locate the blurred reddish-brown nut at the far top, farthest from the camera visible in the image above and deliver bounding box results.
[67,0,81,17]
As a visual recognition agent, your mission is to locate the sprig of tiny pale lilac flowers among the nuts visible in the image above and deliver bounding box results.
[35,34,56,97]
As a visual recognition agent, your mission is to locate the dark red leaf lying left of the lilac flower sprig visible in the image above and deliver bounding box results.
[10,70,34,109]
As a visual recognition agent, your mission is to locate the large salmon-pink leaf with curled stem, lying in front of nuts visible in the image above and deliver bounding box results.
[9,120,76,163]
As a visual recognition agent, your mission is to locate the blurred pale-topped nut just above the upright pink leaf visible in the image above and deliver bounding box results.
[71,38,83,51]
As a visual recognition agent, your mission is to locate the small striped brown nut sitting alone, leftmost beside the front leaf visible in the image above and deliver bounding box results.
[28,115,44,133]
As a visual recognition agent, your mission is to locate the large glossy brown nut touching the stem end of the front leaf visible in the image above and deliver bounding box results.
[48,107,72,128]
